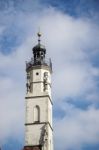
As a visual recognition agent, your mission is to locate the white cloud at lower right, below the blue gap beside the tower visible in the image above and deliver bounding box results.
[54,104,99,150]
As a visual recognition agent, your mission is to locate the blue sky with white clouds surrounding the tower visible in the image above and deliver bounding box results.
[0,0,99,150]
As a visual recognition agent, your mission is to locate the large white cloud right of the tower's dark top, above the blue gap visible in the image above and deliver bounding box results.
[39,10,99,99]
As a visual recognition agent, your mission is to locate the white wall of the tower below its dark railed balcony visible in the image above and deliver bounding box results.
[25,65,53,150]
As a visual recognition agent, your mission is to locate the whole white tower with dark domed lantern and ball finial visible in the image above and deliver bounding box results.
[24,32,53,150]
